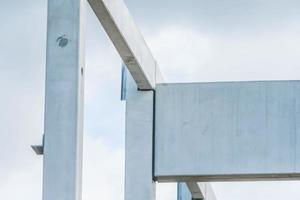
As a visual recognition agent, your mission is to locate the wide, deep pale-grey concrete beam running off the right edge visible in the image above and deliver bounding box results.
[155,81,300,181]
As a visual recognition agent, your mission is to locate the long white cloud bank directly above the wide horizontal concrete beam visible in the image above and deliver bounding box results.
[147,25,300,82]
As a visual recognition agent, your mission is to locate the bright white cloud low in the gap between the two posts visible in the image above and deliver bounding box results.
[83,136,124,200]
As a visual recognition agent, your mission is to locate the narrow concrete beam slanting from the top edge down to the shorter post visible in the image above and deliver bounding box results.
[88,0,161,90]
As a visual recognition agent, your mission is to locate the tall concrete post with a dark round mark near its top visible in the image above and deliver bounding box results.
[43,0,85,200]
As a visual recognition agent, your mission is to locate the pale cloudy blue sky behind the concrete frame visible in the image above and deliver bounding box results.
[0,0,300,200]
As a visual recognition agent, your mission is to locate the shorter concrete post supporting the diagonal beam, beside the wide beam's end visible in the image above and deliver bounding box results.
[125,76,155,200]
